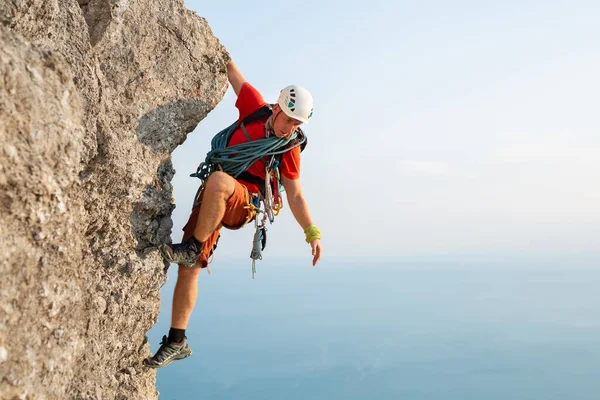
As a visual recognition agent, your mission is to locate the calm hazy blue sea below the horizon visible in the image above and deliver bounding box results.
[148,261,600,400]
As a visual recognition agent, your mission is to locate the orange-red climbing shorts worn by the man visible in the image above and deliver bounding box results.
[182,181,254,268]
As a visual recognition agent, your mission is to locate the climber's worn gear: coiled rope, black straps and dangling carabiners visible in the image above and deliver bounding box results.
[190,105,306,279]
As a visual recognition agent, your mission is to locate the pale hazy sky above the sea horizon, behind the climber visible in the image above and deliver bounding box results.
[173,0,600,266]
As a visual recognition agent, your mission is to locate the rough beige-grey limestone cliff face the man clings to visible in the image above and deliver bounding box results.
[0,0,229,399]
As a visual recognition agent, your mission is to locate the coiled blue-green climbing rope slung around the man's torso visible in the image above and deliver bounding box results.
[190,122,306,181]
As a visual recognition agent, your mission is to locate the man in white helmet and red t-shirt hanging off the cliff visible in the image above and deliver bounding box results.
[144,61,321,368]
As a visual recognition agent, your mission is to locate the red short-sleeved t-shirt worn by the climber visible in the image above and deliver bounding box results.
[228,82,300,193]
